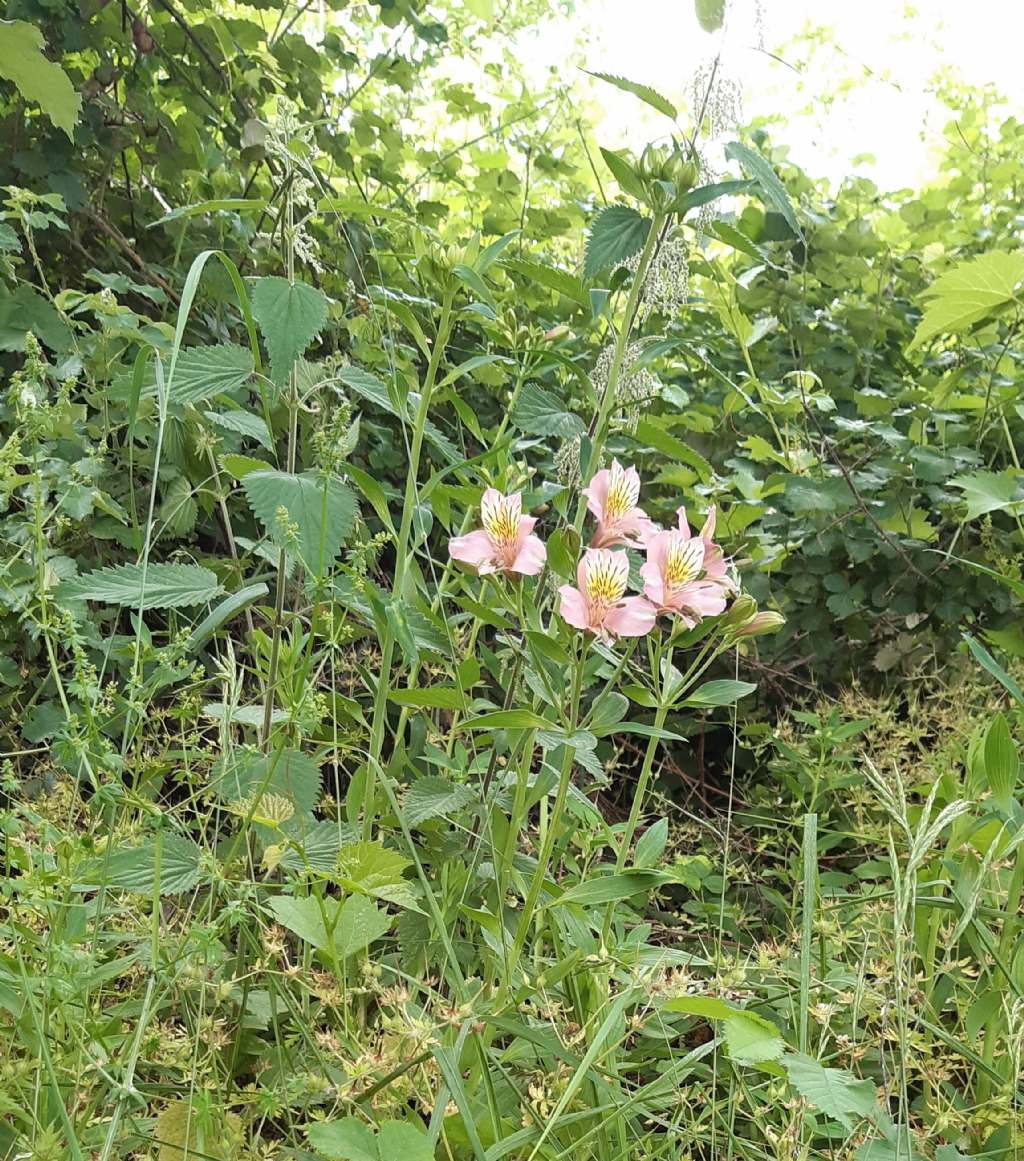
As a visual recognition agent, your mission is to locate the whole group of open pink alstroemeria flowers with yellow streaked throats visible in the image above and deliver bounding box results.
[448,460,737,642]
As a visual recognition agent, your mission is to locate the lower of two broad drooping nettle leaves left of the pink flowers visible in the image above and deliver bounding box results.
[241,470,356,576]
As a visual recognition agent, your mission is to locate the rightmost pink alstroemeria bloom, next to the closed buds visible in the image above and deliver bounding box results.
[640,507,735,628]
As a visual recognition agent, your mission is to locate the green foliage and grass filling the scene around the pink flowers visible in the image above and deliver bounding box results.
[0,0,1024,1161]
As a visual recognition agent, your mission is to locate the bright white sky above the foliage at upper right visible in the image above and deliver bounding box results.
[515,0,1024,189]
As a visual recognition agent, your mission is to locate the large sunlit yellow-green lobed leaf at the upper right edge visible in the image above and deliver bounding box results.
[907,250,1024,351]
